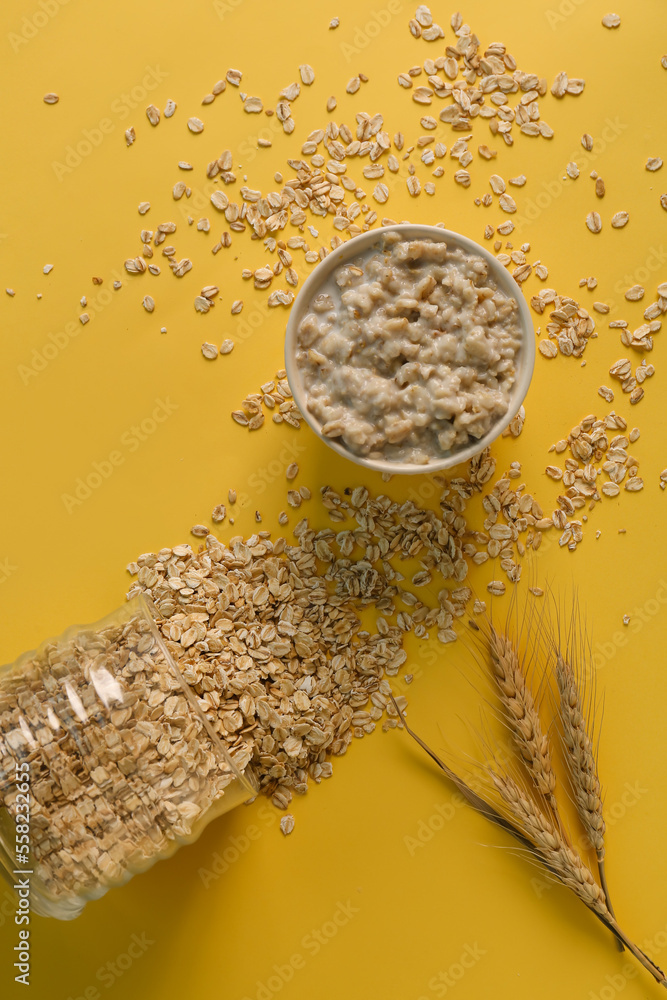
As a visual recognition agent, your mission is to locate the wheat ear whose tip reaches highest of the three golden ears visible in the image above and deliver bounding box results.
[488,626,560,822]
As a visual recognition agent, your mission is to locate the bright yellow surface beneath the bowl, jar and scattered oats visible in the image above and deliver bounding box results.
[0,0,667,1000]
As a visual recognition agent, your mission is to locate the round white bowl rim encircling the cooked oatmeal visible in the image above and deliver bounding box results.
[285,223,535,475]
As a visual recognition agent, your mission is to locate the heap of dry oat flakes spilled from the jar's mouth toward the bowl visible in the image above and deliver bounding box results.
[128,480,480,808]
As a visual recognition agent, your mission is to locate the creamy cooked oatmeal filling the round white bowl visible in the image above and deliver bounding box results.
[296,232,521,465]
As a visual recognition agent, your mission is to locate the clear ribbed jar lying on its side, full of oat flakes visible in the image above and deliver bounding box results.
[0,595,256,920]
